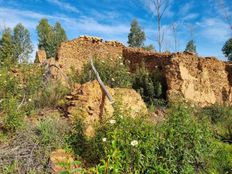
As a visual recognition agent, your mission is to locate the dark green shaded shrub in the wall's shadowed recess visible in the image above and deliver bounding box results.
[132,65,166,105]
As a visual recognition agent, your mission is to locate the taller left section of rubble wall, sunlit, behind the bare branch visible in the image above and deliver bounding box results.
[56,36,124,73]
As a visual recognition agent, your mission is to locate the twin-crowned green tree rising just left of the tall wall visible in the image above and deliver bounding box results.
[37,18,67,58]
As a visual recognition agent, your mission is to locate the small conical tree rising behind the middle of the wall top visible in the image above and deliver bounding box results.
[128,19,146,47]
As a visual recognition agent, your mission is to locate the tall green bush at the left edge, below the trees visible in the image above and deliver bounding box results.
[0,64,43,131]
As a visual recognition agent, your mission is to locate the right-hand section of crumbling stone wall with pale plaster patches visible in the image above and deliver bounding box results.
[123,48,232,106]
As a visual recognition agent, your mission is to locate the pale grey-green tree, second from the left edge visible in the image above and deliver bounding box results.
[13,23,33,61]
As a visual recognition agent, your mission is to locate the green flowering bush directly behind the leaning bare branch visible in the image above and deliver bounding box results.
[75,58,131,88]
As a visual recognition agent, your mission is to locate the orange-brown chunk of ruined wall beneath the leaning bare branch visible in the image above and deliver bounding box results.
[64,80,147,137]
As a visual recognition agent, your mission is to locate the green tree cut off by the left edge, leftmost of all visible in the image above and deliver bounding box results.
[0,28,15,62]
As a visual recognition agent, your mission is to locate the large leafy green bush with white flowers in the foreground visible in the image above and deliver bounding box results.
[69,102,218,173]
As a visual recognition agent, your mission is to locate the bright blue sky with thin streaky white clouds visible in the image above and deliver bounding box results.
[0,0,232,60]
